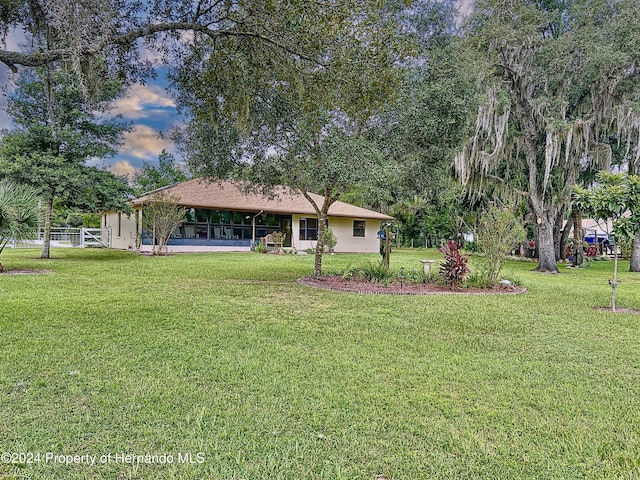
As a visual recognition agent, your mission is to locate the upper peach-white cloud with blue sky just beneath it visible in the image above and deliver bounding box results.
[111,84,176,120]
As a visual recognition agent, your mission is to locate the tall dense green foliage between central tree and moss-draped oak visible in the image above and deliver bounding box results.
[369,2,476,248]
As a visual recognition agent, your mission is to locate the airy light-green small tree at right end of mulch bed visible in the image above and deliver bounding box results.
[478,205,526,283]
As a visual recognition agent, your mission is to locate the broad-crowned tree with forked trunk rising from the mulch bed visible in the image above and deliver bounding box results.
[180,2,410,276]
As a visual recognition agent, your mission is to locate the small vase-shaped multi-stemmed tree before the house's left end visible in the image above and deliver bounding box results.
[142,192,186,255]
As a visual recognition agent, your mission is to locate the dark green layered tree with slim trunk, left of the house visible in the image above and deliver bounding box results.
[0,68,129,258]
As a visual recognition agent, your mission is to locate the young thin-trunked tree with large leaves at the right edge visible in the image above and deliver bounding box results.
[572,171,640,312]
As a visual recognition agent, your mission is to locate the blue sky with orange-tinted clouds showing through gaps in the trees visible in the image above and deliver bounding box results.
[0,0,473,180]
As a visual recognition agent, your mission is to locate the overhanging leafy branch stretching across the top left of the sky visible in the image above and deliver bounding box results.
[0,0,350,80]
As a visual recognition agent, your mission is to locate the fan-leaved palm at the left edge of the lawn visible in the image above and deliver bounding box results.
[0,180,42,272]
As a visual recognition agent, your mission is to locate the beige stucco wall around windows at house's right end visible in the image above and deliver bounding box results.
[292,215,380,253]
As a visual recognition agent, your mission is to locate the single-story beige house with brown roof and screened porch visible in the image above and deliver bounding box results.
[102,179,393,253]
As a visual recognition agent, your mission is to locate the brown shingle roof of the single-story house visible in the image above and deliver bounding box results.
[132,179,393,220]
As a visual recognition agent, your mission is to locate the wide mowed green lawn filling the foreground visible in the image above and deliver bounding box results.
[0,250,640,480]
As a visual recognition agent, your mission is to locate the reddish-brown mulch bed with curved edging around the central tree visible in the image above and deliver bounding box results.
[297,275,527,295]
